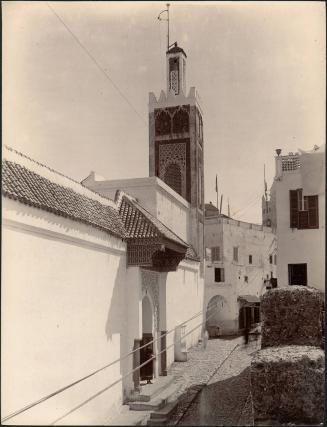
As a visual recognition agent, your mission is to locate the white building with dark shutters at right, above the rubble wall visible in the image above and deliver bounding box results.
[270,147,325,291]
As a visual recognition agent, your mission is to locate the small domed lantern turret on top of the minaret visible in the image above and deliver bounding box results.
[166,42,187,95]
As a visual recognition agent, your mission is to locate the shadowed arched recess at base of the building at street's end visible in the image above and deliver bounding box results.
[206,295,229,338]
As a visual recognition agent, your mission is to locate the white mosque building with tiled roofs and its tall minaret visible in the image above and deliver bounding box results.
[2,45,205,425]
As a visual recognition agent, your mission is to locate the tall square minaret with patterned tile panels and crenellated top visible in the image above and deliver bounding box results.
[149,36,204,270]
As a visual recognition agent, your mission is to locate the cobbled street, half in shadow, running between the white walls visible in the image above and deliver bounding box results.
[168,338,259,425]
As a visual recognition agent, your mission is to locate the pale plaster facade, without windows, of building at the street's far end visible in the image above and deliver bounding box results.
[205,217,276,334]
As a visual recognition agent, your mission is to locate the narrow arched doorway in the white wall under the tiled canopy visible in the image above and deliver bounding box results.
[140,296,154,382]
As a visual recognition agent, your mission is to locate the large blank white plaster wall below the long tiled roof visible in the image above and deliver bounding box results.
[1,199,131,425]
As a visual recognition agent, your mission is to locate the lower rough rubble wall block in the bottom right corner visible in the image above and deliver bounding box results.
[251,345,325,424]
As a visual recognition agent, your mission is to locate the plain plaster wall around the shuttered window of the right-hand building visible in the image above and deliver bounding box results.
[274,170,325,291]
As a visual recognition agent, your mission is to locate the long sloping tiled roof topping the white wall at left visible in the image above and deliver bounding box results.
[2,153,126,238]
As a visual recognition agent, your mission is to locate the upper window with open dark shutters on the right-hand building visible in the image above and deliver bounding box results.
[290,188,319,229]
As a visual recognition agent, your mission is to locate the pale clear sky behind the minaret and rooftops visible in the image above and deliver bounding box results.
[2,1,325,223]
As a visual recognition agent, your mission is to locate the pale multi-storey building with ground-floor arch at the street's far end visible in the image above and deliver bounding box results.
[204,205,276,335]
